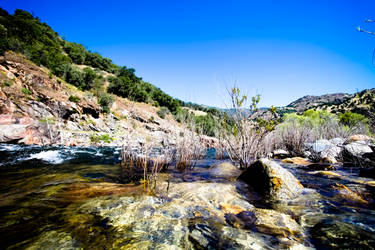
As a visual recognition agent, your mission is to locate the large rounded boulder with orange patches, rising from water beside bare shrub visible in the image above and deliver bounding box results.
[238,159,303,200]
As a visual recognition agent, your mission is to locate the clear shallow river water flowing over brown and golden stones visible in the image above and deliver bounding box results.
[0,145,375,249]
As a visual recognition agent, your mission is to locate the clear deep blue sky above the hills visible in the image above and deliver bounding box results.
[0,0,375,106]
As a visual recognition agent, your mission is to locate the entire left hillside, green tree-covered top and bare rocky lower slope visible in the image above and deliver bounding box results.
[0,8,228,145]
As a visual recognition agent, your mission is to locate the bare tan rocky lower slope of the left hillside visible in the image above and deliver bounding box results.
[0,52,194,145]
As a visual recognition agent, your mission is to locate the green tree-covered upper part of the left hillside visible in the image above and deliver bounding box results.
[0,9,182,113]
